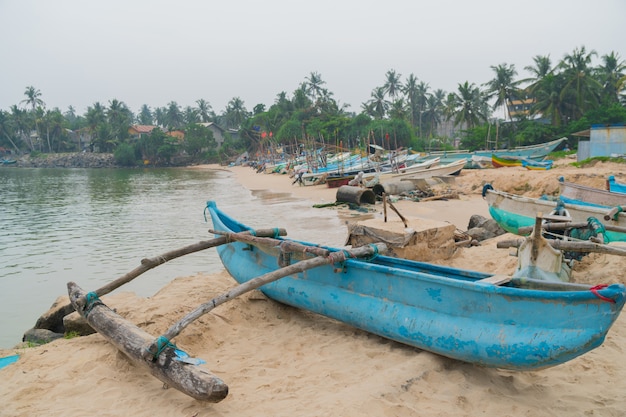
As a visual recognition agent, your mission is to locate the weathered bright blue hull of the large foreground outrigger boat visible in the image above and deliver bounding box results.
[207,201,626,370]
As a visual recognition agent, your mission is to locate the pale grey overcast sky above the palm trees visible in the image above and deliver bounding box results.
[0,0,626,114]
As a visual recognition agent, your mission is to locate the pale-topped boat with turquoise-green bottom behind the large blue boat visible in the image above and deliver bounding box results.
[482,184,626,243]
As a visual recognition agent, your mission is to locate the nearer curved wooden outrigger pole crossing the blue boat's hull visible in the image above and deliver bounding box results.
[143,243,387,359]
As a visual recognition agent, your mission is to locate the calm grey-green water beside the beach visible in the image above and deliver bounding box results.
[0,167,345,348]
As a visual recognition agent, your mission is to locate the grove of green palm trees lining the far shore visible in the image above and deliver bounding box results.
[0,46,626,166]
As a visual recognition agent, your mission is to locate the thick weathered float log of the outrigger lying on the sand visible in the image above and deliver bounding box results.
[67,282,228,402]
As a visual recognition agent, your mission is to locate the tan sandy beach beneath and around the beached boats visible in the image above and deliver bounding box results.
[0,161,626,417]
